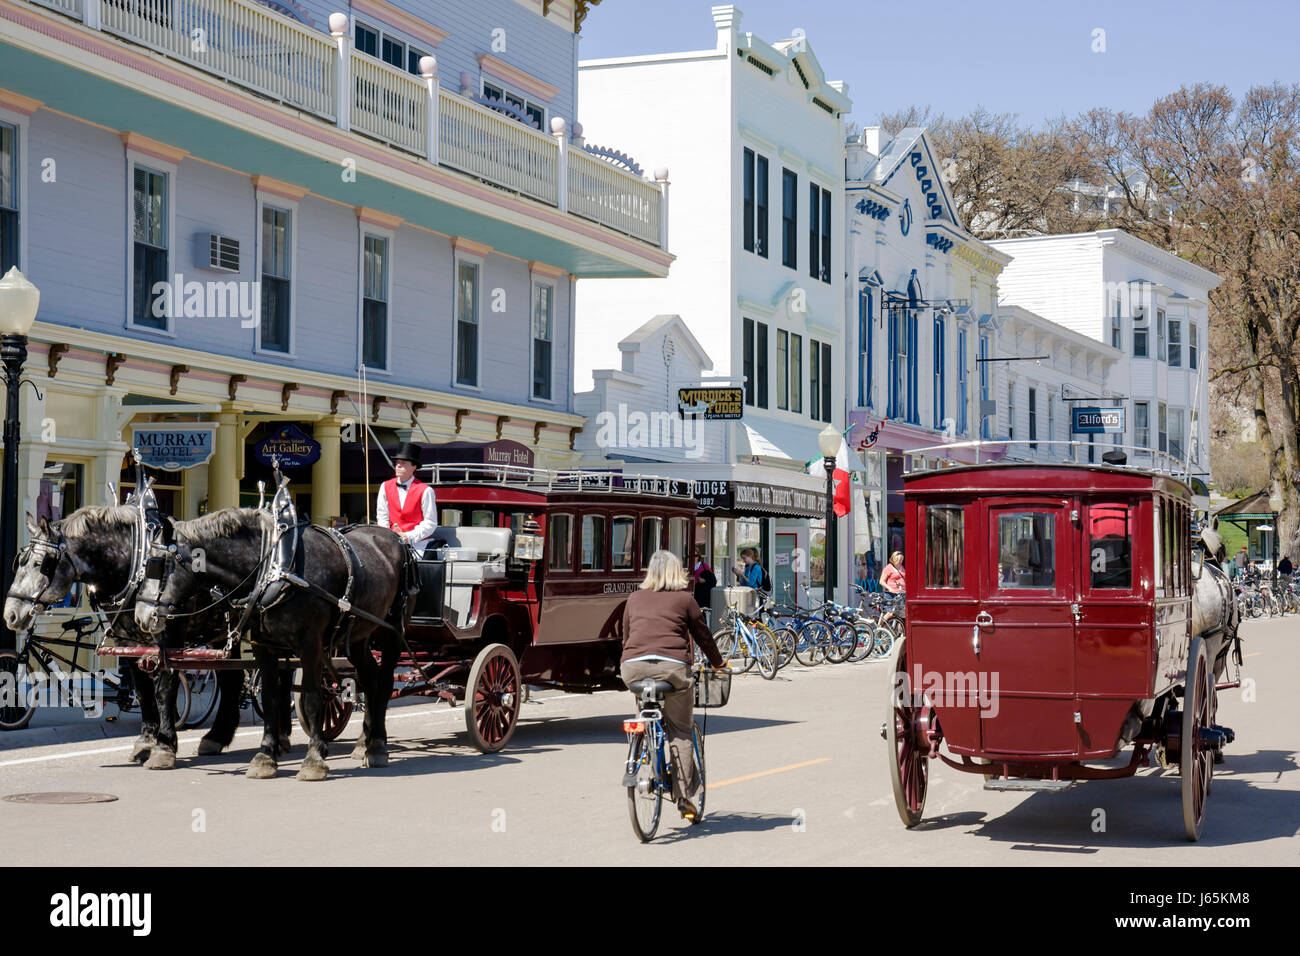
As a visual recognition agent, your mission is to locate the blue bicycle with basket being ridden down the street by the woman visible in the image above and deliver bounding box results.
[623,666,731,843]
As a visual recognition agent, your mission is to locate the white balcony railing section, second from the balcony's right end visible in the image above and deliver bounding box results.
[438,90,559,206]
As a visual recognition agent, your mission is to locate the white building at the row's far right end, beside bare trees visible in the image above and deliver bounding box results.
[989,229,1221,476]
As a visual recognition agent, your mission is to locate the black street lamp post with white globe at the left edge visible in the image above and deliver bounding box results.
[0,265,40,650]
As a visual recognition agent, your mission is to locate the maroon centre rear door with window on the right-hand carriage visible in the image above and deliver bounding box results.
[972,498,1079,756]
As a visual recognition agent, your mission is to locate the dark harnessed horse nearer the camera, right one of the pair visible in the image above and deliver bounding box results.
[135,509,410,780]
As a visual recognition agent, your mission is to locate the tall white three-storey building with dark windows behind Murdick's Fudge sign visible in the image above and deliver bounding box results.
[575,5,850,596]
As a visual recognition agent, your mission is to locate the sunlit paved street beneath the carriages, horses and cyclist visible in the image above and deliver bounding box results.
[0,617,1300,866]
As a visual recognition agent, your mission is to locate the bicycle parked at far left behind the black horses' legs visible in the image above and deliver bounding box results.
[0,611,190,730]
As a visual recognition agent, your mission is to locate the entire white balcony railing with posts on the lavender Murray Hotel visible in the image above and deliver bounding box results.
[20,0,667,248]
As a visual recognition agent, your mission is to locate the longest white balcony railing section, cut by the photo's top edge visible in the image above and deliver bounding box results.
[100,0,338,120]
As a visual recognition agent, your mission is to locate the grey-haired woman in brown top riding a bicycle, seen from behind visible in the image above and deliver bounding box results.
[620,550,723,821]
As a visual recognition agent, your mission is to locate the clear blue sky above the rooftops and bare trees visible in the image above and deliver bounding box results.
[579,0,1300,124]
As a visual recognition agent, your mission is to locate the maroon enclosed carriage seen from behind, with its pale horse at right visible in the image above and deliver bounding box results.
[881,464,1242,840]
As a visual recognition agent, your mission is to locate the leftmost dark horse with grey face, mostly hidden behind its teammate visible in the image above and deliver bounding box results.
[4,505,243,770]
